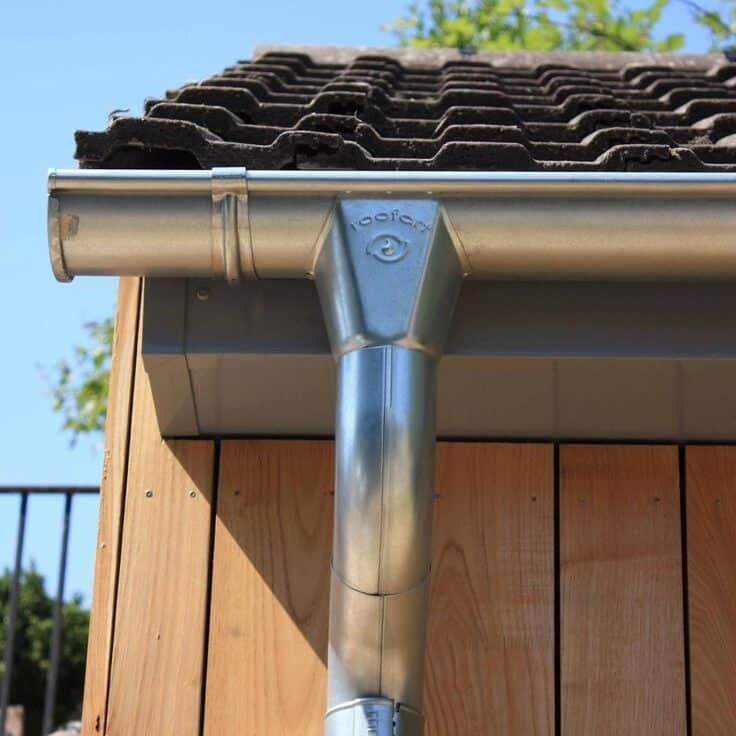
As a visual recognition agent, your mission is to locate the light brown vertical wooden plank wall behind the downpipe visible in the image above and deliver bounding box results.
[84,290,736,736]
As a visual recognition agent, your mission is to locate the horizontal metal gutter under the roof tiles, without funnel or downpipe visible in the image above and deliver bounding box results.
[49,169,736,281]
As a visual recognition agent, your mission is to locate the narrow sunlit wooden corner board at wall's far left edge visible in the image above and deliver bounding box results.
[82,278,140,736]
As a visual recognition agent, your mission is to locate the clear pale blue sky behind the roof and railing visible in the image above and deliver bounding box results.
[0,0,708,595]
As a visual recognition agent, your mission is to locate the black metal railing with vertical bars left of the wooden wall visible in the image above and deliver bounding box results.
[0,486,100,736]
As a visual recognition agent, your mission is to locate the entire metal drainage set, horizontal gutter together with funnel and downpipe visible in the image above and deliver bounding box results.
[49,169,736,736]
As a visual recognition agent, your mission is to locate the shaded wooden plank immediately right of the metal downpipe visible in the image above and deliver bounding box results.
[424,443,554,736]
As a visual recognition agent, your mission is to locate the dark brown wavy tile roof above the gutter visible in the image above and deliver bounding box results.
[76,47,736,171]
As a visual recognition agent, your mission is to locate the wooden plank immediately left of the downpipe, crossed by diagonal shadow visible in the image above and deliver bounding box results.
[204,440,334,736]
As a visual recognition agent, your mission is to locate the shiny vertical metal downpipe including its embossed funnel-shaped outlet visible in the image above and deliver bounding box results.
[315,199,463,736]
